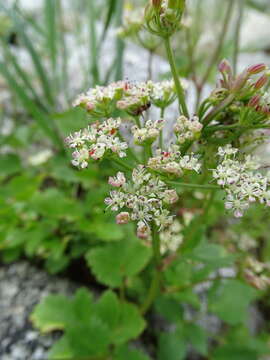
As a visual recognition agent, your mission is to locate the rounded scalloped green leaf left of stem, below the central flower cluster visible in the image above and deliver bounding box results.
[86,239,151,287]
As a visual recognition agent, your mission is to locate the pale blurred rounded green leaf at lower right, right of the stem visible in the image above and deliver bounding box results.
[209,280,257,325]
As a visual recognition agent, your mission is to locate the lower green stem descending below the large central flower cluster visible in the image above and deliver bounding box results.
[141,224,161,315]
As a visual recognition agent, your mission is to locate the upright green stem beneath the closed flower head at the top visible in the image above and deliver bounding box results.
[164,37,189,118]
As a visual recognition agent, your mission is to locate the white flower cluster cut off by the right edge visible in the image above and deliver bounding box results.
[213,145,270,217]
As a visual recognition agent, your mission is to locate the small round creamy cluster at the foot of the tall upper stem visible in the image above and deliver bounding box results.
[174,116,203,144]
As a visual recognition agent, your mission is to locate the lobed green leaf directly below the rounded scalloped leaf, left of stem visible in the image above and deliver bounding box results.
[97,291,145,345]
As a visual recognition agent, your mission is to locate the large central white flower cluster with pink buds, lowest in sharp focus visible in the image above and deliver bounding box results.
[105,165,178,239]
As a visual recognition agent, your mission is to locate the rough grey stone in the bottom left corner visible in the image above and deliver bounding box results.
[0,262,76,360]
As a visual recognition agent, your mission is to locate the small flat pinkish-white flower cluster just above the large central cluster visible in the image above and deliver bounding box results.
[148,145,201,176]
